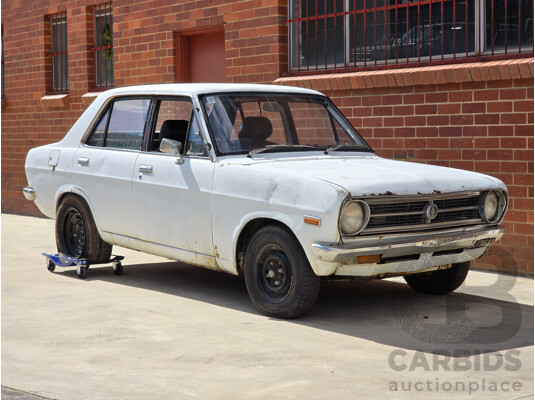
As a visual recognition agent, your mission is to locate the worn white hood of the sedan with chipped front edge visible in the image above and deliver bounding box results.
[222,155,506,196]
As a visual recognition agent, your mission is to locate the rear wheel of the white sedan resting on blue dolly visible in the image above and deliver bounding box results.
[56,196,112,264]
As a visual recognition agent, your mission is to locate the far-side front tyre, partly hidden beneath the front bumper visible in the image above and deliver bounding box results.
[403,261,470,294]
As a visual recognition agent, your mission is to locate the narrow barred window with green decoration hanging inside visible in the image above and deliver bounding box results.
[93,4,114,89]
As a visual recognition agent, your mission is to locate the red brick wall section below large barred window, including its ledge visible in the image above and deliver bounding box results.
[277,59,534,275]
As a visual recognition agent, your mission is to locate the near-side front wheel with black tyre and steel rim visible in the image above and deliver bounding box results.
[244,226,320,318]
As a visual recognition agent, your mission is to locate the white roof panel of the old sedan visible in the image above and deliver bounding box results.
[101,83,322,98]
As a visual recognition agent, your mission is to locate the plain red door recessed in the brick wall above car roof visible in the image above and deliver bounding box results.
[176,28,226,82]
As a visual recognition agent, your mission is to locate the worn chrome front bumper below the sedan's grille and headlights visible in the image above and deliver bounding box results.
[312,226,505,264]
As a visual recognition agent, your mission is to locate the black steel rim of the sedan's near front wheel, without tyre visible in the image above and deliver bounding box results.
[256,245,292,303]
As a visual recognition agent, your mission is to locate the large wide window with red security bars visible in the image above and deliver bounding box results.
[288,0,533,73]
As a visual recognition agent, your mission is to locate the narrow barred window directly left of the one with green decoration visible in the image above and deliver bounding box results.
[50,13,69,93]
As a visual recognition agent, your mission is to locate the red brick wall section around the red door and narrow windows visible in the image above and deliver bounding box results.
[1,0,288,215]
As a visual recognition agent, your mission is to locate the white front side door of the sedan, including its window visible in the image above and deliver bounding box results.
[133,98,214,261]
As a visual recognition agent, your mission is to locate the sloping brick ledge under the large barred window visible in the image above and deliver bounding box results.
[273,58,534,90]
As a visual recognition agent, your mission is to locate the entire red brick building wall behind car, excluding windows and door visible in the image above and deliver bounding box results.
[1,0,533,274]
